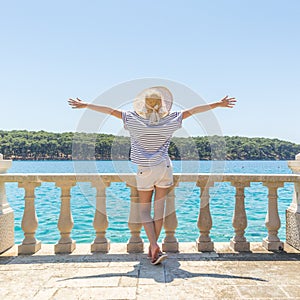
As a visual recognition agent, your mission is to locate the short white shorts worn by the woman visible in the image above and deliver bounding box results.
[136,159,173,191]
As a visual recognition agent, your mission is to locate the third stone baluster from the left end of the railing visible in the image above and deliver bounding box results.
[91,182,110,253]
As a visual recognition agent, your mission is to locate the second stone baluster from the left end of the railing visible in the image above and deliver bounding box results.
[54,181,76,253]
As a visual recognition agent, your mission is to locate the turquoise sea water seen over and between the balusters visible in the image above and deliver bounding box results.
[6,161,293,244]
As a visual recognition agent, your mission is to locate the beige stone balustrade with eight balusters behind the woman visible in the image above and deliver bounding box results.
[0,173,300,254]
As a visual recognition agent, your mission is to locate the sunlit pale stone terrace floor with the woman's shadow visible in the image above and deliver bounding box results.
[0,243,300,300]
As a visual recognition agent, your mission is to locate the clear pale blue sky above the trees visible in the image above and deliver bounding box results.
[0,0,300,144]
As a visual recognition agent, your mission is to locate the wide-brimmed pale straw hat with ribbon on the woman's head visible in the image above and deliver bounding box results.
[133,86,173,124]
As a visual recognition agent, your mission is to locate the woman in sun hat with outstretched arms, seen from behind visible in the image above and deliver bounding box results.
[69,86,236,264]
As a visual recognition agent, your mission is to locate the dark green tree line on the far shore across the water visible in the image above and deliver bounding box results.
[0,130,300,160]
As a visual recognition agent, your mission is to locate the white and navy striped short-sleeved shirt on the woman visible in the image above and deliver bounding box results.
[122,111,182,166]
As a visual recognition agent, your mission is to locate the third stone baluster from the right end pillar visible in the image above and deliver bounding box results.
[196,182,214,252]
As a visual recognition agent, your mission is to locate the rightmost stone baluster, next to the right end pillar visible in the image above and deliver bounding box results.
[262,182,283,251]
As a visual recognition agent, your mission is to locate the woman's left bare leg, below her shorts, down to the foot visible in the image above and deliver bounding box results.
[139,191,159,260]
